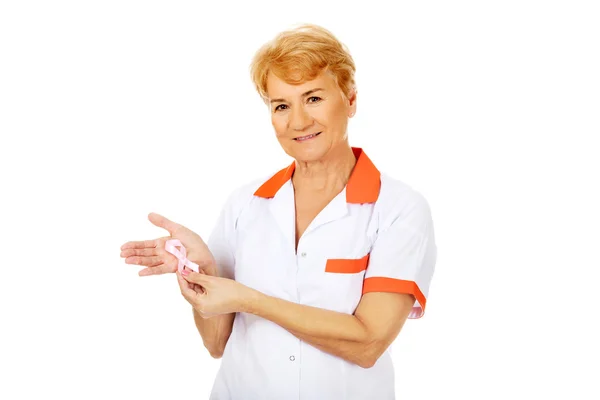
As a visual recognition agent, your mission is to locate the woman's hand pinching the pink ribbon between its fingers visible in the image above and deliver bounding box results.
[177,269,255,318]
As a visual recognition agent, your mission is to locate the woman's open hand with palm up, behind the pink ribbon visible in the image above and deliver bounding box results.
[121,213,217,276]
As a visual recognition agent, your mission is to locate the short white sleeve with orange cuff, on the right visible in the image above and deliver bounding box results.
[363,195,437,319]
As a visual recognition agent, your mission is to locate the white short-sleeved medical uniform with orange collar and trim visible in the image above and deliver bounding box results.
[208,148,437,400]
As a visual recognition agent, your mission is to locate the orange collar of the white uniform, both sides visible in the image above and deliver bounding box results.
[254,147,381,204]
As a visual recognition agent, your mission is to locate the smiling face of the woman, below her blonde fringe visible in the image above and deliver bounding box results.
[267,72,356,161]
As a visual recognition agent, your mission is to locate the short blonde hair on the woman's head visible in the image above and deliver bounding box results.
[250,24,356,102]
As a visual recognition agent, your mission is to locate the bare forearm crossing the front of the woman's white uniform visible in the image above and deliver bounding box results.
[246,292,374,366]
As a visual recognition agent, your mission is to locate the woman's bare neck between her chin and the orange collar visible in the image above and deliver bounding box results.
[292,144,356,193]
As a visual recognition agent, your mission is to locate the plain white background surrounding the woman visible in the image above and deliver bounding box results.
[0,0,600,399]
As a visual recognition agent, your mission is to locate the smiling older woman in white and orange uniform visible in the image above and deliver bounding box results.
[121,25,437,400]
